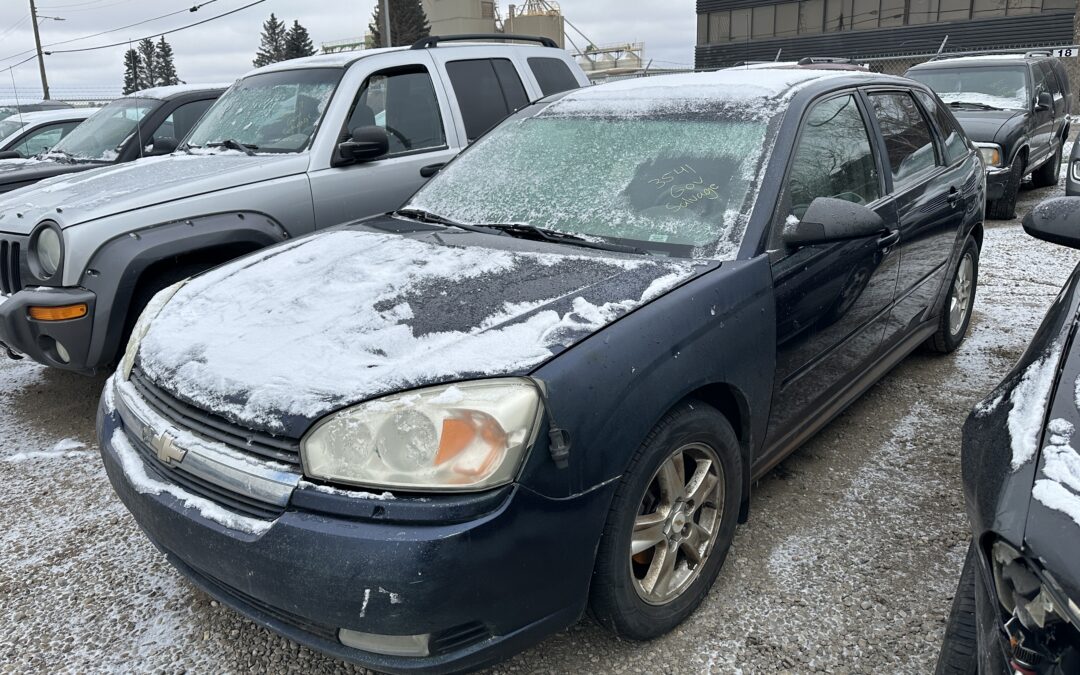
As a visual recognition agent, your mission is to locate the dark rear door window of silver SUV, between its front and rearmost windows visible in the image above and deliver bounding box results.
[446,58,529,141]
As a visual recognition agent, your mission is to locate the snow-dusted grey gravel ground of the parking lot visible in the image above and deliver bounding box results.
[0,169,1080,673]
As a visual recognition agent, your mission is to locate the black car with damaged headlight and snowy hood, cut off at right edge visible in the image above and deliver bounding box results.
[937,197,1080,675]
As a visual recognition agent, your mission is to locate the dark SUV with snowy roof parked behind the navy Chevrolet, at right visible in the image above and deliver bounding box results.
[907,53,1071,218]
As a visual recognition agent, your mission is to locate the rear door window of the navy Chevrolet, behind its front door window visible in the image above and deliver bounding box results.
[870,92,936,189]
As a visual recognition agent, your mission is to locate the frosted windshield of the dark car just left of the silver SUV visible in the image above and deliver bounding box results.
[44,98,161,162]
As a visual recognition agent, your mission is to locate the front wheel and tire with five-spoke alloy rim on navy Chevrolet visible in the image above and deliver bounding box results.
[589,400,743,640]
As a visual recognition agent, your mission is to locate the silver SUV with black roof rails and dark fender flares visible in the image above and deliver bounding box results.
[0,36,588,373]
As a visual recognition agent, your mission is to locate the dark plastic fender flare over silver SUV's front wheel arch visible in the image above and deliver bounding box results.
[80,211,289,368]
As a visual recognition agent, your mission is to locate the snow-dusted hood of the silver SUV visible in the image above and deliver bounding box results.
[0,151,308,233]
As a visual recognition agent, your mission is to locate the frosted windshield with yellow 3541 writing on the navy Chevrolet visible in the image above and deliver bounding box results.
[408,104,771,257]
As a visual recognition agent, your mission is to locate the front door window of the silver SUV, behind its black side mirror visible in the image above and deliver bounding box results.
[346,69,446,156]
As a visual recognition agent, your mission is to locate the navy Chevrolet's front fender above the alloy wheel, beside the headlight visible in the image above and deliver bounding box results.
[523,255,775,496]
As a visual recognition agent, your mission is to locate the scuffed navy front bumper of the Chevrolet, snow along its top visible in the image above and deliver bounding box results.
[97,382,613,673]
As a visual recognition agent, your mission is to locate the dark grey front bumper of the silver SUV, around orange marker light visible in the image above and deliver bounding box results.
[0,288,96,373]
